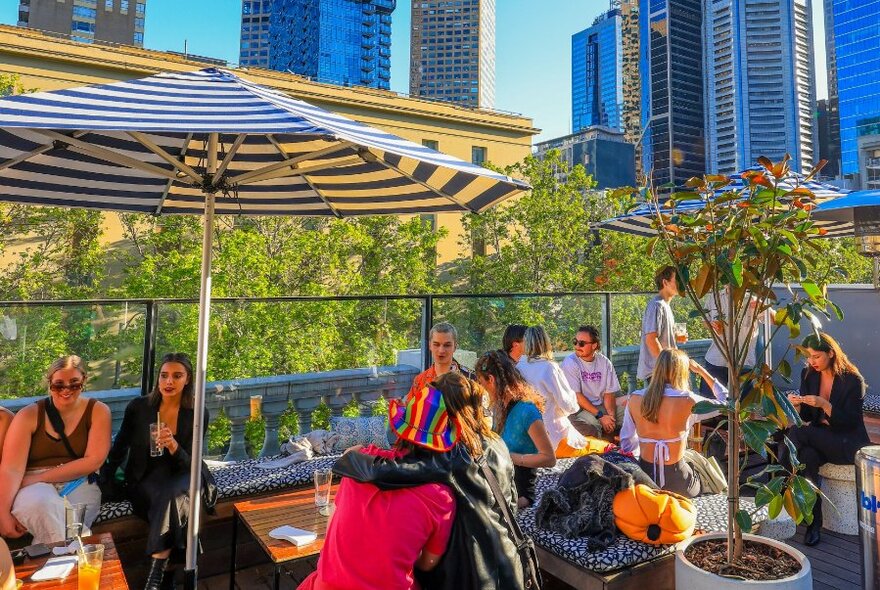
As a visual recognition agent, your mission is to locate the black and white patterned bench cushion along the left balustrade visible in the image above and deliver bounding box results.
[95,455,339,523]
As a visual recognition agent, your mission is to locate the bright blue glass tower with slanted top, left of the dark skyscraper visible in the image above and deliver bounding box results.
[571,8,624,132]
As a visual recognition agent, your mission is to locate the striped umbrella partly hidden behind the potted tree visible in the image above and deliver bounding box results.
[594,172,853,238]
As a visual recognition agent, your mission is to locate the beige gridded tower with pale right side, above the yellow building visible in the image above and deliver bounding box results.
[409,0,495,108]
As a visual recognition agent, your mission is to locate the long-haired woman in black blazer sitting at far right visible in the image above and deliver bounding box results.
[781,332,870,546]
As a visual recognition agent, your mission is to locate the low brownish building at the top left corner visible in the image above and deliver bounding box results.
[18,0,147,47]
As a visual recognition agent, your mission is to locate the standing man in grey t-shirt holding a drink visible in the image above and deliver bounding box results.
[636,266,678,383]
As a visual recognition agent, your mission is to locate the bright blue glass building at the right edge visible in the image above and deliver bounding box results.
[829,0,880,188]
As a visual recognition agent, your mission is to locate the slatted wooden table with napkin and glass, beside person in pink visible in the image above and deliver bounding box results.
[229,484,339,590]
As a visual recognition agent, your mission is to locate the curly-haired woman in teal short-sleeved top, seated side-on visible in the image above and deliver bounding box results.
[476,350,556,508]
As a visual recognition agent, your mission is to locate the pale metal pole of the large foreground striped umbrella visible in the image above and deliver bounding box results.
[183,133,217,590]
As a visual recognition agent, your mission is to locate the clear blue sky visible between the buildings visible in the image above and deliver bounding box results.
[0,0,827,141]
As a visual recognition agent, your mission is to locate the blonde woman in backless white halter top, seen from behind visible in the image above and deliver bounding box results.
[620,349,727,498]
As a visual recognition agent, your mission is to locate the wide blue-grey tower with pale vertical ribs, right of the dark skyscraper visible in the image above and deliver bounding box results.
[703,0,817,174]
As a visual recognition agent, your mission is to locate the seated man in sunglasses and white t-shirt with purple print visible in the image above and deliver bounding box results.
[560,326,624,438]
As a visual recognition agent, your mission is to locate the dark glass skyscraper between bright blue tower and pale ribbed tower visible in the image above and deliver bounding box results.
[639,0,706,185]
